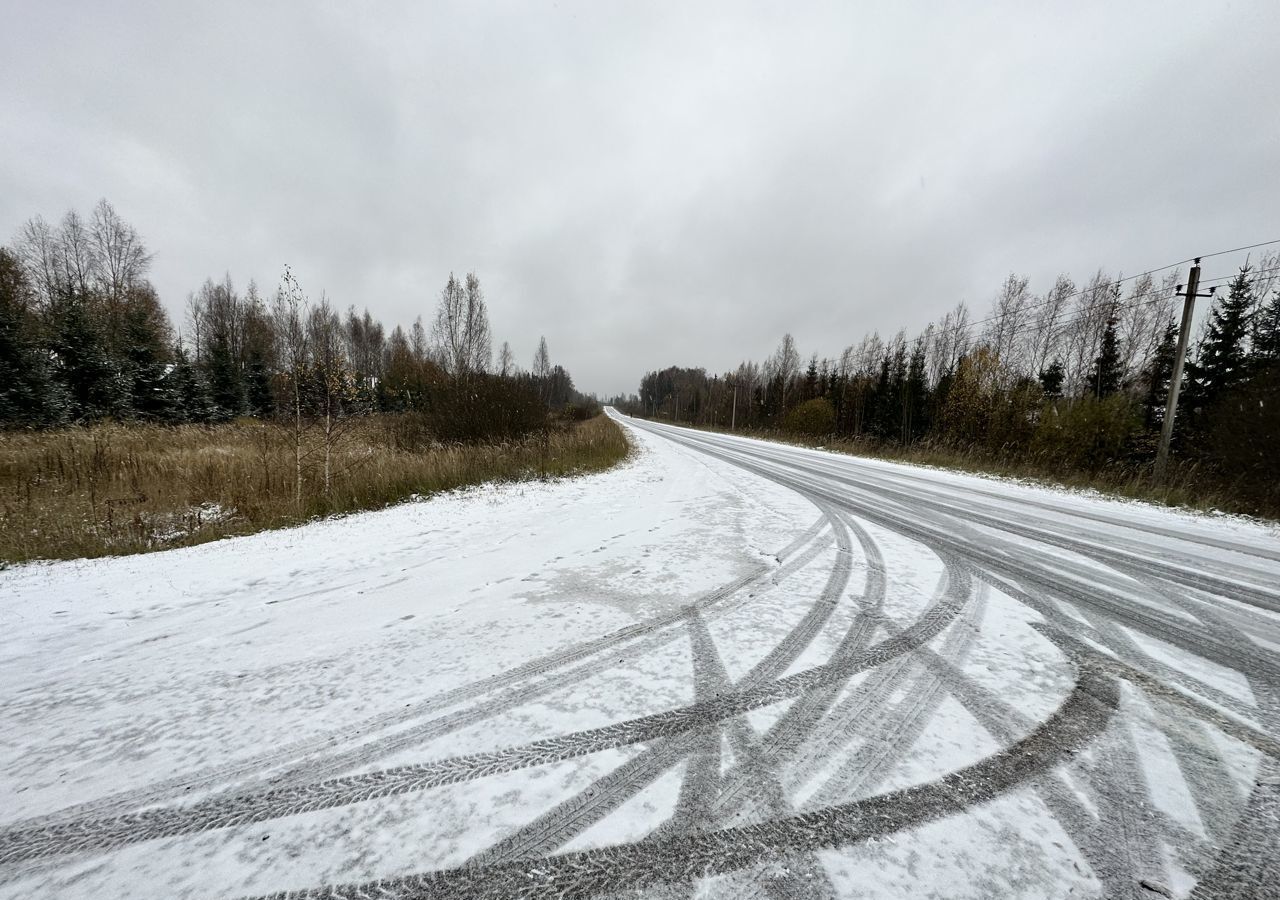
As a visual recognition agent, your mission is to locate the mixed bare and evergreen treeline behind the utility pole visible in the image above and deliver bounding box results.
[611,253,1280,512]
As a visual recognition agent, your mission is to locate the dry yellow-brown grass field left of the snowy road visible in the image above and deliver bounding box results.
[0,415,627,563]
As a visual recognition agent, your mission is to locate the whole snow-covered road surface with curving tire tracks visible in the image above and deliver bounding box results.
[0,417,1280,899]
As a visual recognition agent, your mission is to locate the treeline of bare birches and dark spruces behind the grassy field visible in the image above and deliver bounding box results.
[0,200,594,447]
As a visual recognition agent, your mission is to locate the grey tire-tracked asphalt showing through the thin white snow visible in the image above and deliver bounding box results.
[0,421,1280,899]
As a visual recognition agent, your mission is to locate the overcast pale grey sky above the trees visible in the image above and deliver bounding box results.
[0,0,1280,393]
